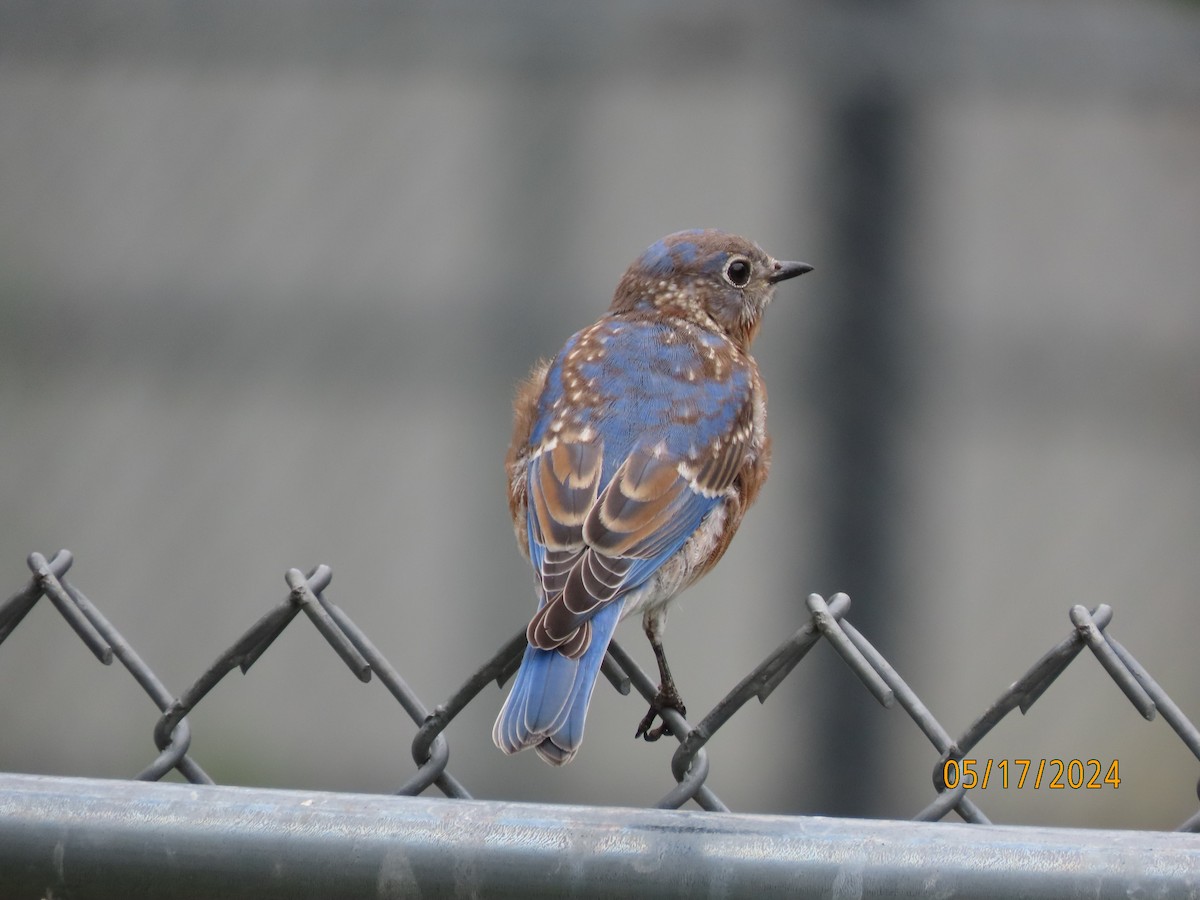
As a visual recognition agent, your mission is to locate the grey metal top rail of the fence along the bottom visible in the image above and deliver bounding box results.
[0,774,1200,898]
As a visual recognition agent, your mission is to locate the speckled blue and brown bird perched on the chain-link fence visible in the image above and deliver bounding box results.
[492,229,812,766]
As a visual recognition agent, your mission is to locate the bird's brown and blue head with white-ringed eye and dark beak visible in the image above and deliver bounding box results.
[611,229,812,352]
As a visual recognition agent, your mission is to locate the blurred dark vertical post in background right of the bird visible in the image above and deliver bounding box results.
[797,47,911,816]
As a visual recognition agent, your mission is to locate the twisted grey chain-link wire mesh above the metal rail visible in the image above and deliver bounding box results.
[0,550,1200,832]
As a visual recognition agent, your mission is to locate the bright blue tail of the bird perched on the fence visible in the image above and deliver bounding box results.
[492,599,625,766]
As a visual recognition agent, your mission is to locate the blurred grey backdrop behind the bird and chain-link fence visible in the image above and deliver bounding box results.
[0,0,1200,827]
